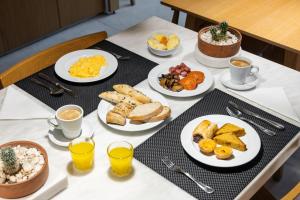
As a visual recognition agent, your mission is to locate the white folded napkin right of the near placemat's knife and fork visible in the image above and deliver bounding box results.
[230,87,299,121]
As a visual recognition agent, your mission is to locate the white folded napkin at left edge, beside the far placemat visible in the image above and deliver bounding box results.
[0,86,51,119]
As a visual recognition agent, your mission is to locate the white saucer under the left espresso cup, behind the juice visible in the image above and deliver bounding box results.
[48,122,94,147]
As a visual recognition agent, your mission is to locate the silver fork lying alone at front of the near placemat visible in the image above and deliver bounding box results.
[161,156,215,194]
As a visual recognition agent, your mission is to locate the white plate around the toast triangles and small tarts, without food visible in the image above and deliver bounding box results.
[180,115,261,167]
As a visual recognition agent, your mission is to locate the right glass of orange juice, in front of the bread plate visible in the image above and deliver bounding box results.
[107,141,133,177]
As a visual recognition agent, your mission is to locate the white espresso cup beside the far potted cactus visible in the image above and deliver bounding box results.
[229,56,259,85]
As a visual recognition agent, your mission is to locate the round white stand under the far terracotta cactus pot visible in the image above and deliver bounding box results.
[194,45,242,68]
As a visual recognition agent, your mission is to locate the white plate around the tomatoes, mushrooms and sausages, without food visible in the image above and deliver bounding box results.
[148,61,214,97]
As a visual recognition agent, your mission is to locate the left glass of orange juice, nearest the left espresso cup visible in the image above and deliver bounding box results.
[69,137,95,171]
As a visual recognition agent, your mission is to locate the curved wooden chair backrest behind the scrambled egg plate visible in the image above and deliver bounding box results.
[0,31,107,89]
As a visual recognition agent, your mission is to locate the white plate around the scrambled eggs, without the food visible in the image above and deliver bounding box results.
[54,49,118,83]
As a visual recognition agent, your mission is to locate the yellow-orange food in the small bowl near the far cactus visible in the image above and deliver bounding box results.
[147,34,179,50]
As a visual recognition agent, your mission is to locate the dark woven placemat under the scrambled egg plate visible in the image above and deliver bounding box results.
[16,40,157,115]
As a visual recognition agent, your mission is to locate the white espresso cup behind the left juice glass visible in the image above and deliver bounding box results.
[48,104,83,139]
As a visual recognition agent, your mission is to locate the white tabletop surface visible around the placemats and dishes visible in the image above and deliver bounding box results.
[0,17,300,200]
